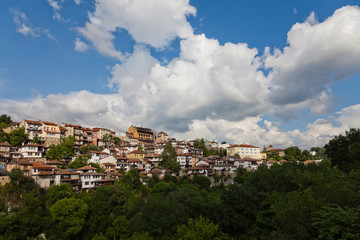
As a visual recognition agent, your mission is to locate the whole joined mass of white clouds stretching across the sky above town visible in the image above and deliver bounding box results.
[0,5,360,148]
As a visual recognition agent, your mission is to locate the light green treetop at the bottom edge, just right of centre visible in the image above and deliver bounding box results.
[175,216,230,240]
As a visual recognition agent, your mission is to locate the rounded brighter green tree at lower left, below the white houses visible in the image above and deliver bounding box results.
[49,198,88,239]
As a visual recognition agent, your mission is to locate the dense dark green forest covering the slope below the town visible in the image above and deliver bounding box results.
[0,129,360,240]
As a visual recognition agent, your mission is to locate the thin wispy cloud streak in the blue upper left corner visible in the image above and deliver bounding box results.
[10,9,57,41]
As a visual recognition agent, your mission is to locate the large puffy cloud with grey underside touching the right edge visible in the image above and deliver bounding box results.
[264,6,360,117]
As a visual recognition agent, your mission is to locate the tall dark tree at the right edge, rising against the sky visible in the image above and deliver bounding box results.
[325,128,360,172]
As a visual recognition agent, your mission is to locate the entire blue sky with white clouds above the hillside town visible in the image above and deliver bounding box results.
[0,0,360,149]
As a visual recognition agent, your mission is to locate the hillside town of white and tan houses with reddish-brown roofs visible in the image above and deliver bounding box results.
[0,119,320,191]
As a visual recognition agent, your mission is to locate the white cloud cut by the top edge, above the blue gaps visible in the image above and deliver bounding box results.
[78,0,196,60]
